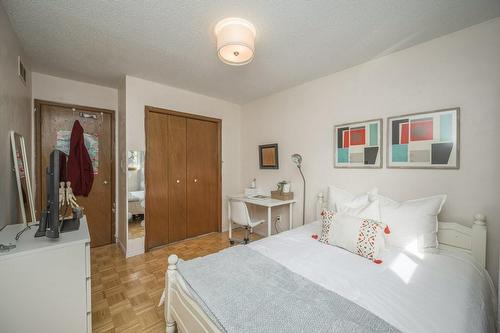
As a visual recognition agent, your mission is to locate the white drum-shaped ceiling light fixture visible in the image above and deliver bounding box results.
[215,17,256,66]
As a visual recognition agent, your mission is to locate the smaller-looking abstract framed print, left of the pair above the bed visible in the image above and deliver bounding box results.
[333,119,382,168]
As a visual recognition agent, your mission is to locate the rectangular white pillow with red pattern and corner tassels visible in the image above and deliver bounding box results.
[329,214,386,263]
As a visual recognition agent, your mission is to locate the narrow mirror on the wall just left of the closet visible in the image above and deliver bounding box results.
[127,150,146,240]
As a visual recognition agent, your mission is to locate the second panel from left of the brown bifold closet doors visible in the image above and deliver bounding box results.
[164,115,187,243]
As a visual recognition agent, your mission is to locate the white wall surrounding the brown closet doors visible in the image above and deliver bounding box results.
[126,76,241,230]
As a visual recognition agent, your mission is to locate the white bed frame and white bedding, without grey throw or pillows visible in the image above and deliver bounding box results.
[165,196,496,333]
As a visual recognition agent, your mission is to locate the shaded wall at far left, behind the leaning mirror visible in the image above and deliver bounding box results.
[0,6,32,229]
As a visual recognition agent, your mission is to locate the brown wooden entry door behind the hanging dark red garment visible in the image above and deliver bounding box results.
[35,101,115,247]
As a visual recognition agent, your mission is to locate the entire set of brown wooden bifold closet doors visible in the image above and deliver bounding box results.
[145,107,221,250]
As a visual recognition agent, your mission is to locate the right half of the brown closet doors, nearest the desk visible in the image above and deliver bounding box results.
[187,119,220,237]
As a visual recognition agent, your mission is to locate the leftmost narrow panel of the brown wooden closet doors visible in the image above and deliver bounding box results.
[145,112,170,250]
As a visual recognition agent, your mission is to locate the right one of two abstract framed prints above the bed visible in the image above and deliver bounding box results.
[387,108,460,169]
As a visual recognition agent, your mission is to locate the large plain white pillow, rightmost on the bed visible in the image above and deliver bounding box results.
[379,195,446,250]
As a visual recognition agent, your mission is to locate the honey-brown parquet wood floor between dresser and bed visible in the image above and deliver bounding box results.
[91,230,260,333]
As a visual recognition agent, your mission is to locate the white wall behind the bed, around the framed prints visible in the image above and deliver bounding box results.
[242,18,500,281]
